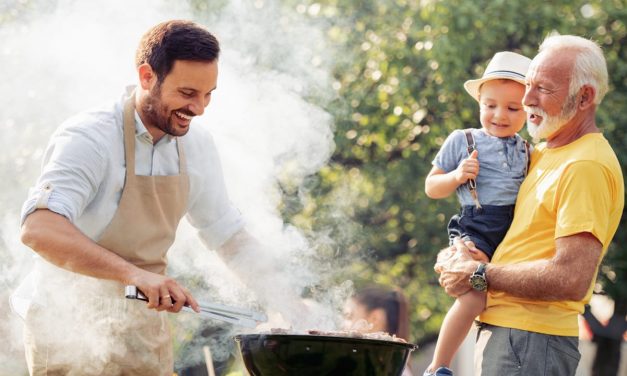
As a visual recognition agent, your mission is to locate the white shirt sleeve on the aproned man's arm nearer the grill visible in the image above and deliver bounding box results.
[184,134,245,249]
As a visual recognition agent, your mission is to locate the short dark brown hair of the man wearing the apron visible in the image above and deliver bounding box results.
[135,20,220,82]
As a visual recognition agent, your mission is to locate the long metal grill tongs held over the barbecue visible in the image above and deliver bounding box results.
[124,286,268,328]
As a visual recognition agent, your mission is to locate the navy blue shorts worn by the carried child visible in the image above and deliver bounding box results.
[448,205,514,260]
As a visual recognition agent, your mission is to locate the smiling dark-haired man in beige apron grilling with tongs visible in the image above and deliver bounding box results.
[14,21,296,375]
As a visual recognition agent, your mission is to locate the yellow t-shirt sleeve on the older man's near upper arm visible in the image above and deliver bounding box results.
[555,161,616,248]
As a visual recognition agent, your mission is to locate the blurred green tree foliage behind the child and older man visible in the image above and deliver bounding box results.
[286,0,627,356]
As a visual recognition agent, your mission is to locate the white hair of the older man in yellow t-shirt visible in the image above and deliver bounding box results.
[539,35,608,105]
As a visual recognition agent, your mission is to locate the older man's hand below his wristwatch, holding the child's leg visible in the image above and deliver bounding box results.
[436,239,479,297]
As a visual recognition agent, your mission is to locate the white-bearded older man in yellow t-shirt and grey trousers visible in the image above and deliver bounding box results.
[440,35,624,376]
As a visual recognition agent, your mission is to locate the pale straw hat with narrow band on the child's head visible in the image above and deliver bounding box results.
[464,51,531,101]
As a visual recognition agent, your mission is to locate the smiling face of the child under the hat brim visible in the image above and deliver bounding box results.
[479,80,527,137]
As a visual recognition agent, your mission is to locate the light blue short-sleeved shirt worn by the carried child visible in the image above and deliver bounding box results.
[433,128,528,206]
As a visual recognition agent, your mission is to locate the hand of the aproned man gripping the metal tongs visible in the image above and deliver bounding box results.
[129,268,200,313]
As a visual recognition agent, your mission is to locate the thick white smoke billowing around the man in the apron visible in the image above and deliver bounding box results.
[0,0,349,374]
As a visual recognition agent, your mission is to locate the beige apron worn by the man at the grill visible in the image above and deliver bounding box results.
[24,95,189,376]
